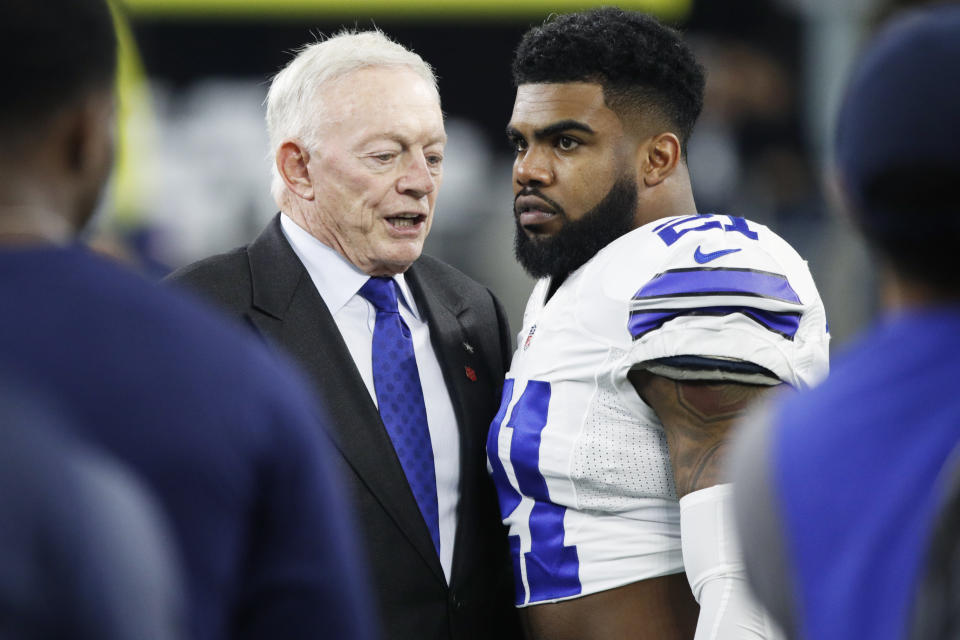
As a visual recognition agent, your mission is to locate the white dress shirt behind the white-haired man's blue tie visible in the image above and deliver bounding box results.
[280,214,460,582]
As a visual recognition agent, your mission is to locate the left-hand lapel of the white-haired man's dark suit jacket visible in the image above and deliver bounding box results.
[249,216,446,582]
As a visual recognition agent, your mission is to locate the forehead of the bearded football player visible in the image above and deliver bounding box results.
[509,82,619,132]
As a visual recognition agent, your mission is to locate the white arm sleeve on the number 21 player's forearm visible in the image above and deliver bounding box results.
[680,484,783,640]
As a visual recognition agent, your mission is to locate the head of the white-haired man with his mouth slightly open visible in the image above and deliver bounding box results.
[267,31,446,276]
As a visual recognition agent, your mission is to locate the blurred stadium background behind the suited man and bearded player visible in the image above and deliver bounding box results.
[99,0,936,347]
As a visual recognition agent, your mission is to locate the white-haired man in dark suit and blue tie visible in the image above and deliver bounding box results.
[172,31,519,640]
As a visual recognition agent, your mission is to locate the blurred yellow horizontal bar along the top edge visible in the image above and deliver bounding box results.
[123,0,693,20]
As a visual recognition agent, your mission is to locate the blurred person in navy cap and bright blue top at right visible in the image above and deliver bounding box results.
[732,4,960,640]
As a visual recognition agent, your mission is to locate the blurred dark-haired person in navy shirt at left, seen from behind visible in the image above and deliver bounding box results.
[0,0,369,640]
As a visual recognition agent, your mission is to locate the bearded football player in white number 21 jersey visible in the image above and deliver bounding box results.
[488,8,829,640]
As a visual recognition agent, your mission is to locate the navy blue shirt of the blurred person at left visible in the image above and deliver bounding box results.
[0,247,371,640]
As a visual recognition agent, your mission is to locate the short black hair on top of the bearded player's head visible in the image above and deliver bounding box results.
[513,7,705,147]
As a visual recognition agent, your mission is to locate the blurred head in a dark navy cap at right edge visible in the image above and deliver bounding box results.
[834,4,960,307]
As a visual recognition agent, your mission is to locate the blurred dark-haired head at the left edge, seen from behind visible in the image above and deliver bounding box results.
[0,0,117,242]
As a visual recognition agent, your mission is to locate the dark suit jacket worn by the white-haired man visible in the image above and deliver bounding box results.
[171,215,520,640]
